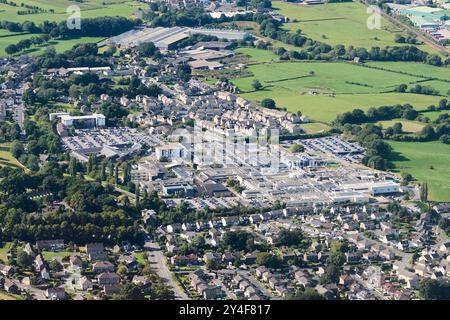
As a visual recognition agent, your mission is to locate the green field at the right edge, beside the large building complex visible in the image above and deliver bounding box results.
[389,141,450,202]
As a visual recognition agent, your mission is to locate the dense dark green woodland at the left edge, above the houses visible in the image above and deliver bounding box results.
[0,161,143,243]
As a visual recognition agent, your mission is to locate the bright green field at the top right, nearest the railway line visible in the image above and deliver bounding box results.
[272,1,438,51]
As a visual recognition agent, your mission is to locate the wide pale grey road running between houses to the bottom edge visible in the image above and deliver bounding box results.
[145,242,190,300]
